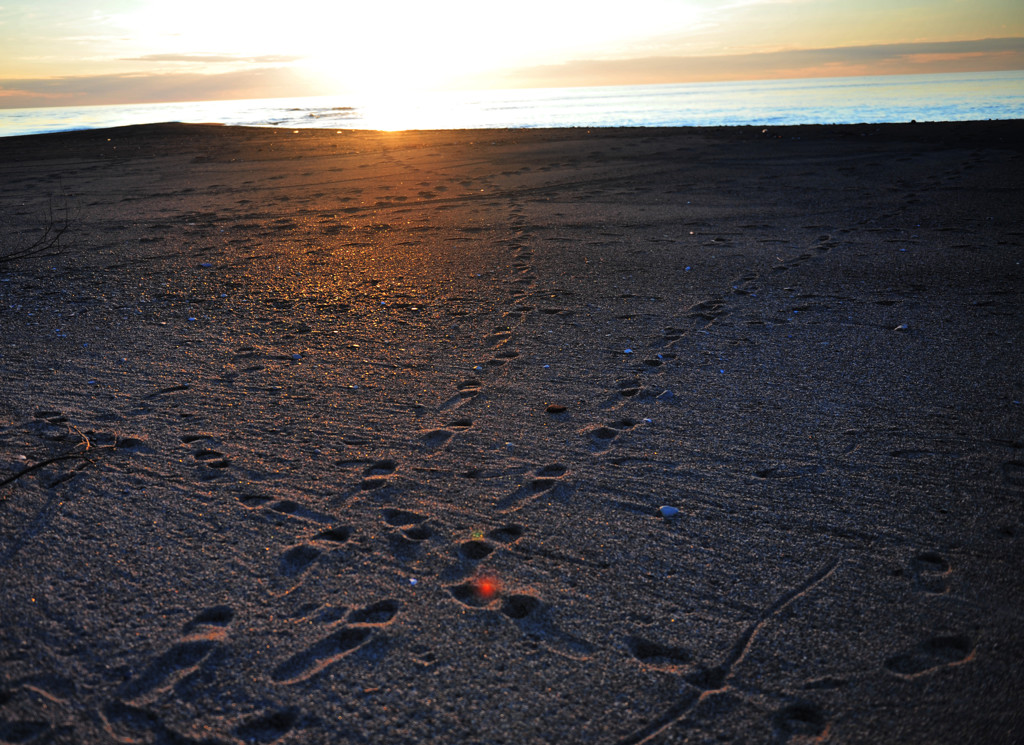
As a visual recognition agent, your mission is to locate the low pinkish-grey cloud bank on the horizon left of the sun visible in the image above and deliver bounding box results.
[0,67,324,108]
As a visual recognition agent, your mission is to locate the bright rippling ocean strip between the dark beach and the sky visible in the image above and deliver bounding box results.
[0,71,1024,136]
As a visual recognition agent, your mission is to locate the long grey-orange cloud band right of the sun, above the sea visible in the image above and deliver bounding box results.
[485,37,1024,87]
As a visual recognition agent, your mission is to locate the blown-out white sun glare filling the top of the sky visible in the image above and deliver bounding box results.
[112,0,706,96]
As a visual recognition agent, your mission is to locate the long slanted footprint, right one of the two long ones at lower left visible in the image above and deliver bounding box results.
[270,599,399,686]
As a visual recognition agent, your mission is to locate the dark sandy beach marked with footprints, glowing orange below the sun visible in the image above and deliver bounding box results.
[0,122,1024,745]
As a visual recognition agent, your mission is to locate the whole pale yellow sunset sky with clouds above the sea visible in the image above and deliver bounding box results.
[0,0,1024,108]
